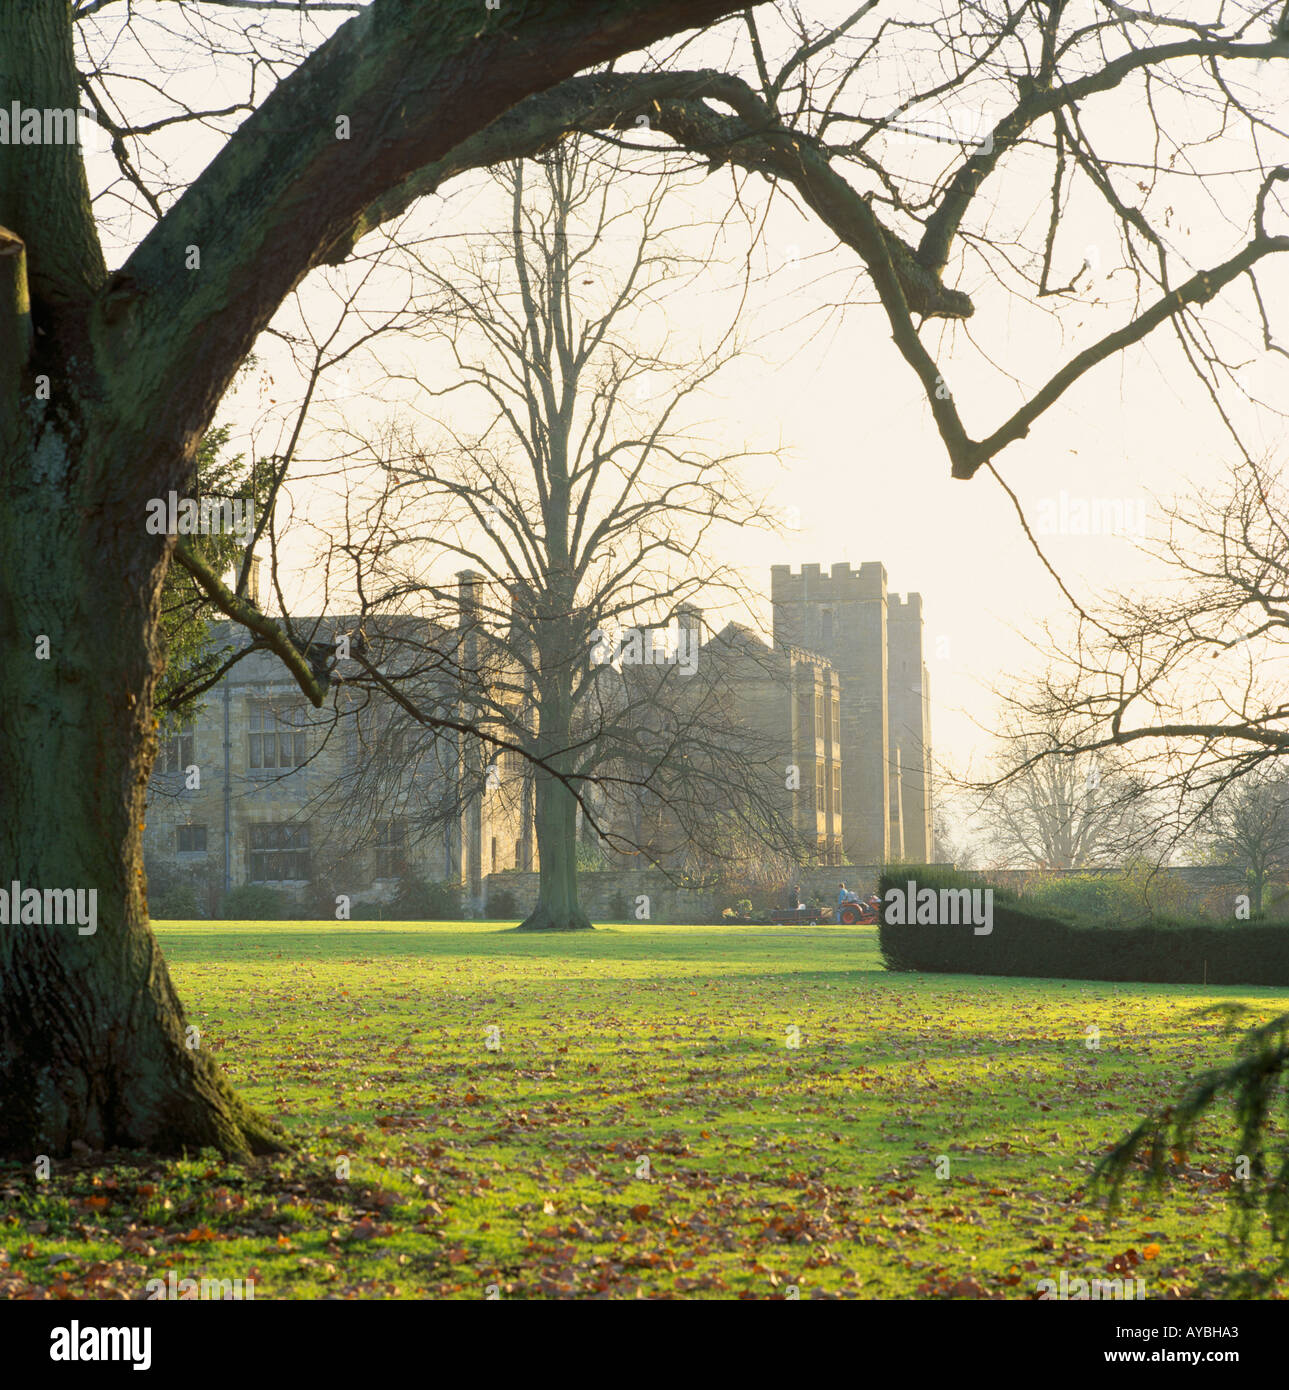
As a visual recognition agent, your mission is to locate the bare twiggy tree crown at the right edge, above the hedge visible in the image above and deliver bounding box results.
[1010,464,1289,844]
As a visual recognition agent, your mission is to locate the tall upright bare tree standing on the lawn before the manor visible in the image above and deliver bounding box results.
[322,140,784,930]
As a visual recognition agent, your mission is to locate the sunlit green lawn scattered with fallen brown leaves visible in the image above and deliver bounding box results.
[0,923,1289,1298]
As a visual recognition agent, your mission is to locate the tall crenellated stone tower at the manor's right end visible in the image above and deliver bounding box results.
[770,562,933,865]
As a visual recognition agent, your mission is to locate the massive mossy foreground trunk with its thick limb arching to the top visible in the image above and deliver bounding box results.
[0,0,736,1156]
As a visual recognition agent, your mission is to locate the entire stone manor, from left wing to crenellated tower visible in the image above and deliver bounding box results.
[145,562,933,916]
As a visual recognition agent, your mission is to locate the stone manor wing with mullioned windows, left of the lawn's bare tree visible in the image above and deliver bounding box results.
[143,617,537,916]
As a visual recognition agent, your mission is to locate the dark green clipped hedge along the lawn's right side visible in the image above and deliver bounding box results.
[877,865,1289,986]
